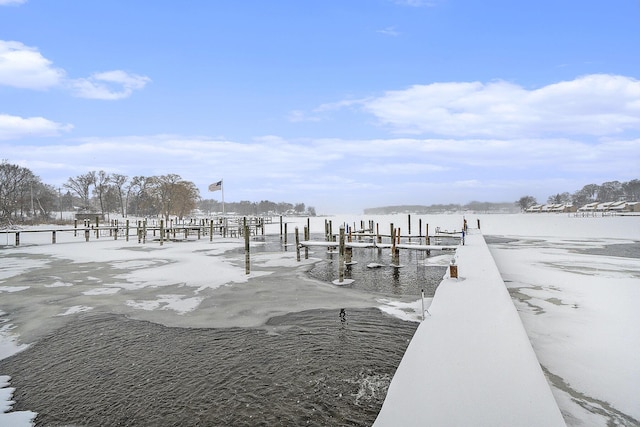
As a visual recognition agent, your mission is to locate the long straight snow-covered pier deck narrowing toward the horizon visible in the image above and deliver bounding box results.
[374,230,565,427]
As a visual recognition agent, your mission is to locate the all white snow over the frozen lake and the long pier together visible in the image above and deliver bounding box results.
[0,214,640,426]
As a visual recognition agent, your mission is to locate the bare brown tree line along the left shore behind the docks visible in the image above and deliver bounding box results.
[0,160,315,225]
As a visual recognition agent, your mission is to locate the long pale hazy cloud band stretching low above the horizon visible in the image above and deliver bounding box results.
[0,133,640,213]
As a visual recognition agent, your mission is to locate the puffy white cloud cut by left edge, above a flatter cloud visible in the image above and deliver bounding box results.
[0,40,65,90]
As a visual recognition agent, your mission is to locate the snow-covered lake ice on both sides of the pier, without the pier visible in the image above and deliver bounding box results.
[0,214,640,426]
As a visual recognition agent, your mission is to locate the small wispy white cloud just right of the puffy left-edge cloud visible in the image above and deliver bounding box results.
[69,70,151,100]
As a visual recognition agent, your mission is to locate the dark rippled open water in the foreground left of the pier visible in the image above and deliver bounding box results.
[0,309,417,426]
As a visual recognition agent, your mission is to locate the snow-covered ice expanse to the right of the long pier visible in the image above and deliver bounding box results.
[484,215,640,426]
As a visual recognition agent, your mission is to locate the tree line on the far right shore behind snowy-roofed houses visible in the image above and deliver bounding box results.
[515,179,640,210]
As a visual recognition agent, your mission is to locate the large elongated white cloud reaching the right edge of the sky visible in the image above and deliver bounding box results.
[362,74,640,137]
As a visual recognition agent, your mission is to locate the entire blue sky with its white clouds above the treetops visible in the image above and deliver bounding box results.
[0,0,640,213]
